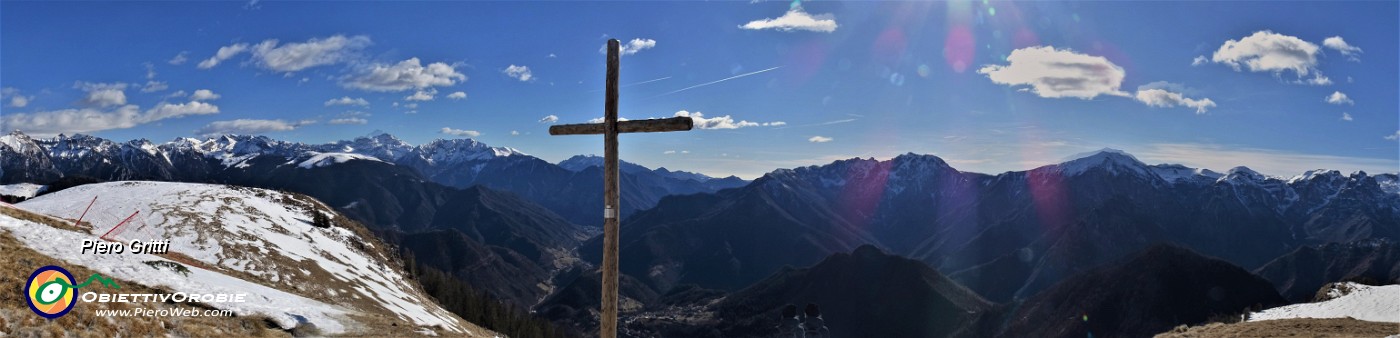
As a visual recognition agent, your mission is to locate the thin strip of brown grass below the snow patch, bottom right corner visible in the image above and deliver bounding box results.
[1156,318,1400,338]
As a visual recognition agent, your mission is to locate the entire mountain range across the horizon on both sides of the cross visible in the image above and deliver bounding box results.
[0,133,1400,335]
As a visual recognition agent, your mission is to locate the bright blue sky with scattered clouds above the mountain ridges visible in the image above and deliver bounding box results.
[0,1,1400,178]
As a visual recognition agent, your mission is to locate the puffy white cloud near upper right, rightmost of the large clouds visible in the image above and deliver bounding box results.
[1211,31,1319,77]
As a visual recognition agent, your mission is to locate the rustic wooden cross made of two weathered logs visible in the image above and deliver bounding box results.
[549,39,694,338]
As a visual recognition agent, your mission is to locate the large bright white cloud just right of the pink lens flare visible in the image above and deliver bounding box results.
[977,46,1128,100]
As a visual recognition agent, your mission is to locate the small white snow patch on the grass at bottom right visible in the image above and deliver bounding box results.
[1249,283,1400,323]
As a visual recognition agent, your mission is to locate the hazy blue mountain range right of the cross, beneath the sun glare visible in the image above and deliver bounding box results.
[580,150,1400,302]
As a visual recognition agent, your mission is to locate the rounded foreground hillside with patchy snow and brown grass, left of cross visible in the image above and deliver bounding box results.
[20,181,481,332]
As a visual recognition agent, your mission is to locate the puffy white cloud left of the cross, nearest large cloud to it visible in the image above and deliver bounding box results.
[340,58,466,91]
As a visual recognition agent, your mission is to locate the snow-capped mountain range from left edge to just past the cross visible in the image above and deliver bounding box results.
[0,132,748,226]
